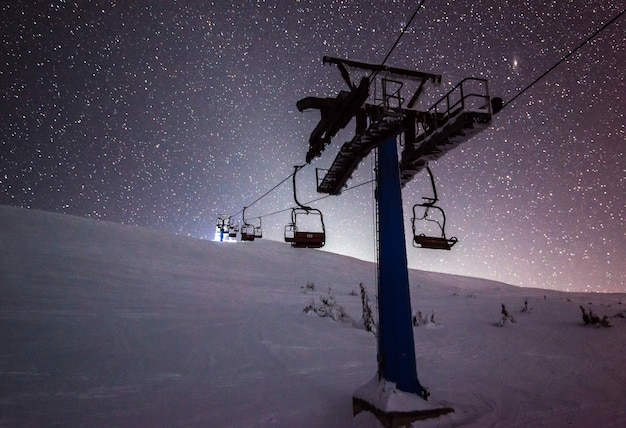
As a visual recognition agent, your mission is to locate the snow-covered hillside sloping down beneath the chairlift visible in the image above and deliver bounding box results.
[0,207,626,427]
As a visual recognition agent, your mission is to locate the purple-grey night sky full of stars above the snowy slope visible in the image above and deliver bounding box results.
[0,0,626,292]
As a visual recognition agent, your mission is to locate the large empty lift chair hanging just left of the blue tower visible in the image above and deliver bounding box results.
[285,165,326,248]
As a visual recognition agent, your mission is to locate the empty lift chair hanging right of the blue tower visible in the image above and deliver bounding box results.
[411,165,458,250]
